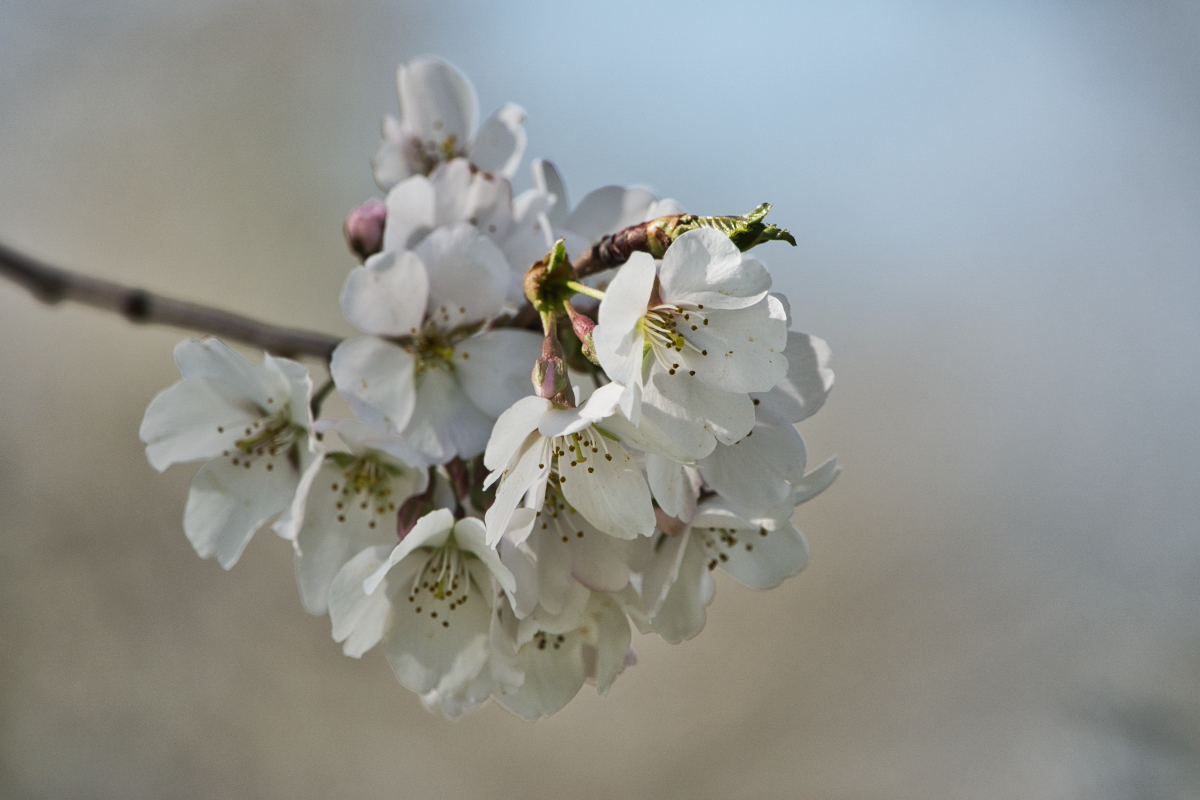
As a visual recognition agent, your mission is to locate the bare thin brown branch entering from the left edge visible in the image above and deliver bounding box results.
[0,243,341,361]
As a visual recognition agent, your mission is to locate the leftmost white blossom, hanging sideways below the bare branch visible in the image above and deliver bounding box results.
[140,338,320,570]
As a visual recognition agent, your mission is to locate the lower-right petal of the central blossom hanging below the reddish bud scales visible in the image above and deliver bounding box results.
[558,433,654,539]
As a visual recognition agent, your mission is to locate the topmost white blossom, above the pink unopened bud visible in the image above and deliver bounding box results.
[372,55,526,191]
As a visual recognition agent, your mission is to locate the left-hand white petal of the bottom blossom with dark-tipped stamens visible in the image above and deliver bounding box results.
[329,545,403,658]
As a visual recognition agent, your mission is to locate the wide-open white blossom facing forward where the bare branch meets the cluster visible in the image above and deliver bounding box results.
[330,223,541,463]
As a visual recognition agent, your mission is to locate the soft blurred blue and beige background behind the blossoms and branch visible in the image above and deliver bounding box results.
[0,0,1200,800]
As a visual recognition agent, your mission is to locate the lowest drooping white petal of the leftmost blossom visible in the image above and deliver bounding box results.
[184,453,300,570]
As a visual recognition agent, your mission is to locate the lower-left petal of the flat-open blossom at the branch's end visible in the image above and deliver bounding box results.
[329,336,416,431]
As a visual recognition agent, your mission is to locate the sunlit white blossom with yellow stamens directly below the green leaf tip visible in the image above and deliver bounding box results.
[593,228,787,457]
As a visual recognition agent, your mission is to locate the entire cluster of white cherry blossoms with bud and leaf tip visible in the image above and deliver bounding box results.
[142,56,839,720]
